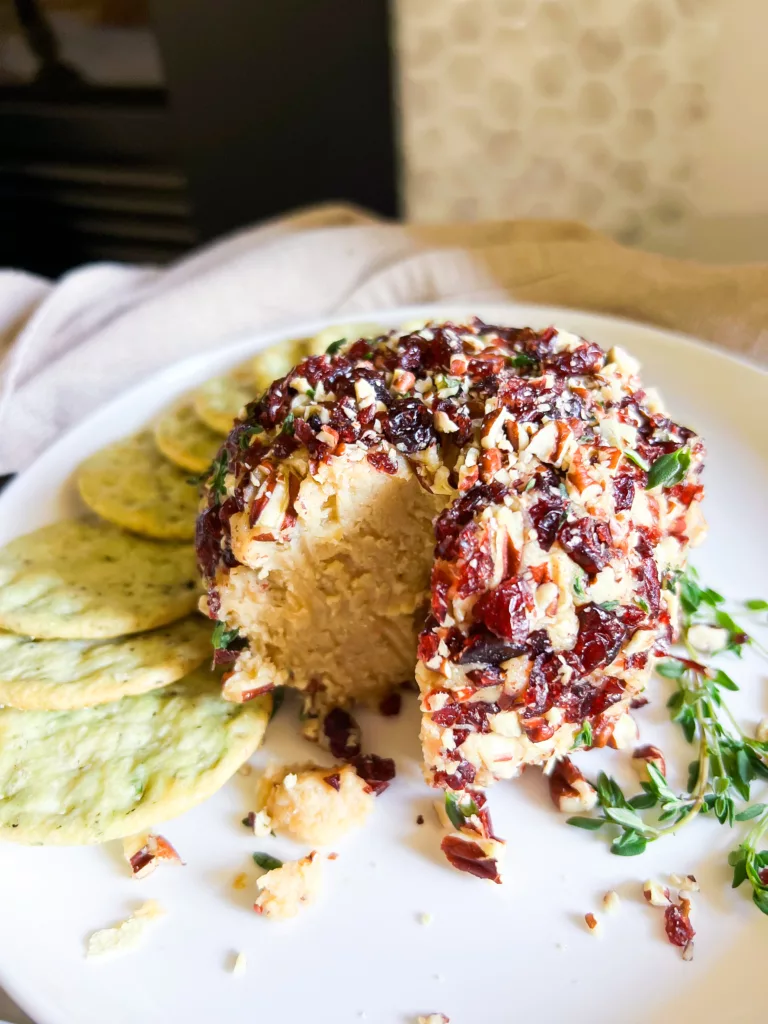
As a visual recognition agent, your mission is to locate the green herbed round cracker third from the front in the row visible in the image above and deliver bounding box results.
[0,519,200,640]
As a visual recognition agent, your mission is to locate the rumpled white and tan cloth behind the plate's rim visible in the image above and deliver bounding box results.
[0,205,768,473]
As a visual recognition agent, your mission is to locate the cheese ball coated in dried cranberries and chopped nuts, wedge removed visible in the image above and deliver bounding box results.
[197,318,705,878]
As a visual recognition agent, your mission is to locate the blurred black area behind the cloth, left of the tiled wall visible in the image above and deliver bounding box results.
[0,0,397,275]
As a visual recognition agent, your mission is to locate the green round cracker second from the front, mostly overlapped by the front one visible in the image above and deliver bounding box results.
[0,615,211,711]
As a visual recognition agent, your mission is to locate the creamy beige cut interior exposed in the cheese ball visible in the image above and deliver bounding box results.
[219,453,446,709]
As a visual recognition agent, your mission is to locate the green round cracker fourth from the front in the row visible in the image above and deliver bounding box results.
[78,431,200,541]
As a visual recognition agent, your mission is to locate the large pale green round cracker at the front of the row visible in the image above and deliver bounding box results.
[0,669,271,845]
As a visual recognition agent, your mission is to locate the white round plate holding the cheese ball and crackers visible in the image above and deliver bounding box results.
[0,305,768,1024]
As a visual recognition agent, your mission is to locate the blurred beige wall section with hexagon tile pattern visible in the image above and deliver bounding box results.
[396,0,722,243]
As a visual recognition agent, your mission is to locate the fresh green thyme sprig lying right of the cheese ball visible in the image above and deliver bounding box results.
[568,569,768,913]
